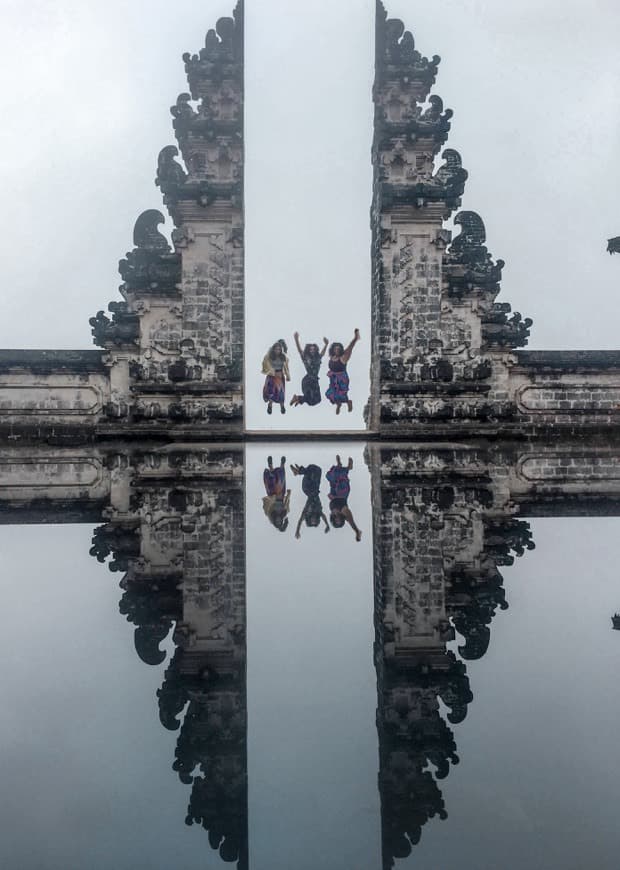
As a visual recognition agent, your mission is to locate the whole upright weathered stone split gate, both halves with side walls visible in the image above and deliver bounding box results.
[0,0,620,440]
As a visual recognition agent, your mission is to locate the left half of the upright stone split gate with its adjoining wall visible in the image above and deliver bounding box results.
[0,0,244,439]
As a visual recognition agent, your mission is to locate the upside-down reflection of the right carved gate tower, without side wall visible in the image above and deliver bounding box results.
[369,445,534,868]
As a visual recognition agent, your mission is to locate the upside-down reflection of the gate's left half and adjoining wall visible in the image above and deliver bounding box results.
[0,444,248,870]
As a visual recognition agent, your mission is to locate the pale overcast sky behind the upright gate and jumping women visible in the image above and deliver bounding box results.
[0,0,620,428]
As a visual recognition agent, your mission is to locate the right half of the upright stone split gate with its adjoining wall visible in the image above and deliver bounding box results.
[367,2,620,437]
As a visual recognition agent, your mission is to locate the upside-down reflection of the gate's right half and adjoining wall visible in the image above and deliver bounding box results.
[368,440,620,870]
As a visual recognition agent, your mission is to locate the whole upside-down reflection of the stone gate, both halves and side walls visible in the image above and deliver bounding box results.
[0,439,620,870]
